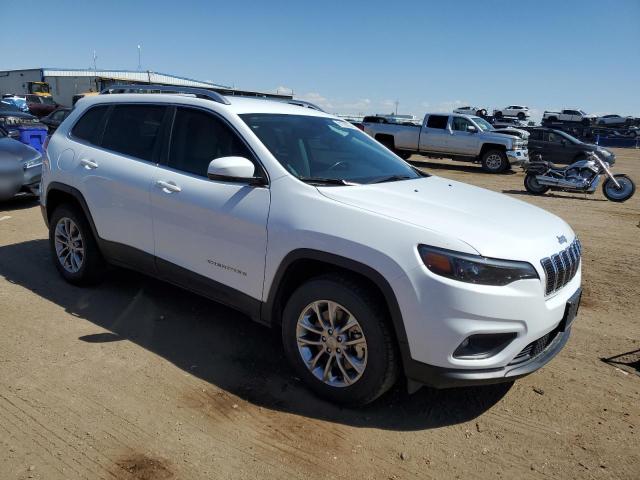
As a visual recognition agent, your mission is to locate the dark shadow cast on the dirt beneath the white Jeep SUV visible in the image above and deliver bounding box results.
[0,240,511,430]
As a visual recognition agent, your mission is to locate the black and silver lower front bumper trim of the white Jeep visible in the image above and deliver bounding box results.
[405,329,571,388]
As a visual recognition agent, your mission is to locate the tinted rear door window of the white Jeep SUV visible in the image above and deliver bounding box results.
[101,105,166,161]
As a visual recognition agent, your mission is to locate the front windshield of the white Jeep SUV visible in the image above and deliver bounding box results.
[240,113,423,184]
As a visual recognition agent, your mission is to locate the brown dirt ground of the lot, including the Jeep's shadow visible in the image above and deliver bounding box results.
[0,150,640,480]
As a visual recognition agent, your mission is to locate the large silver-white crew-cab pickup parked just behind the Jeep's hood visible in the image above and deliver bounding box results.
[363,113,529,173]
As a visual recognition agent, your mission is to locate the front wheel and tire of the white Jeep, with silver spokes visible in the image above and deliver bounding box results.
[282,275,399,405]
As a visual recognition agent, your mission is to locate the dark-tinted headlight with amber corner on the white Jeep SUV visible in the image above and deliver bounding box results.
[418,245,539,286]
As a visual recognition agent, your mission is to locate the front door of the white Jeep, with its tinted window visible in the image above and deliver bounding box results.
[151,107,270,306]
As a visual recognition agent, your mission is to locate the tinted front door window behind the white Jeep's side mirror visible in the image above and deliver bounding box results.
[169,108,253,177]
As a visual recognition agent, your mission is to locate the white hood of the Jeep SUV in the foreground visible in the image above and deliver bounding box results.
[318,176,574,263]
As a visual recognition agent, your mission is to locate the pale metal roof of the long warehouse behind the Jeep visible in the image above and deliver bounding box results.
[42,68,232,89]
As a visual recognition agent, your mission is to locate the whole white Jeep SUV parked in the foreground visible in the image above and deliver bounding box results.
[41,87,581,404]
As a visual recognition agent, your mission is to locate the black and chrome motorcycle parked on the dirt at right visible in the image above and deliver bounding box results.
[524,152,636,202]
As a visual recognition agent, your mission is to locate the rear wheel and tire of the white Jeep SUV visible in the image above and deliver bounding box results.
[49,204,105,285]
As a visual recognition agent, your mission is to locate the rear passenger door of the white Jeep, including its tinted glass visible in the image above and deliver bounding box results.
[71,104,167,261]
